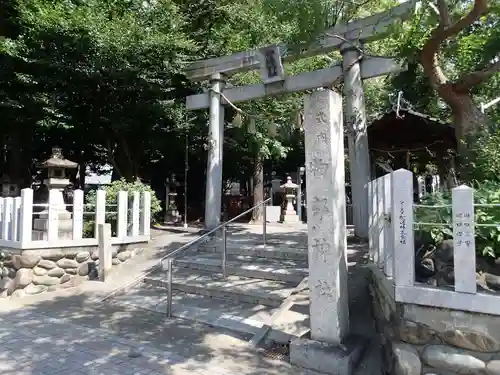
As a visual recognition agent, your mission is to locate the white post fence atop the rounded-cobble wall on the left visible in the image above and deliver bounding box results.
[0,189,151,249]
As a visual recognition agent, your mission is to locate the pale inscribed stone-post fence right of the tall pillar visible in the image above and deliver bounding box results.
[368,169,500,315]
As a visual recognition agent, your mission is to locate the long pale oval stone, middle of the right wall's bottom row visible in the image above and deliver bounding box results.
[422,345,486,375]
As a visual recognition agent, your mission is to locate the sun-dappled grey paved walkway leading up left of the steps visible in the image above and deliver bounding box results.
[0,226,374,375]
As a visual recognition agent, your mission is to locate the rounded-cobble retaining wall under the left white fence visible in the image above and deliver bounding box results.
[0,244,145,298]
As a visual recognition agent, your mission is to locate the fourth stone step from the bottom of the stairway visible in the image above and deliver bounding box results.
[198,240,307,262]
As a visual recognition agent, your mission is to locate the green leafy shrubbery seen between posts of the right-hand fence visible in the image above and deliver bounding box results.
[415,181,500,258]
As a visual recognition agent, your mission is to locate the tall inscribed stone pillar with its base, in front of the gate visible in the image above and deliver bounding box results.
[290,90,364,375]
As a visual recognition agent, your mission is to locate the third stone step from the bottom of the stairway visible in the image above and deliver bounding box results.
[175,253,308,284]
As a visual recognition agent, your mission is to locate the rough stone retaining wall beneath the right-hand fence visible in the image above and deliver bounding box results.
[370,277,500,375]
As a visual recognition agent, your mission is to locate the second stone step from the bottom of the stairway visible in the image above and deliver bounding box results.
[144,268,295,307]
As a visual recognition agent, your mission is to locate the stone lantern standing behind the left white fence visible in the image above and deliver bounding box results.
[33,147,78,240]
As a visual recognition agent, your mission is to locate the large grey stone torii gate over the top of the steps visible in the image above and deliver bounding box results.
[186,1,414,238]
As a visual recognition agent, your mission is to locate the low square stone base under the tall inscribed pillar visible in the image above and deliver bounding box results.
[290,335,369,375]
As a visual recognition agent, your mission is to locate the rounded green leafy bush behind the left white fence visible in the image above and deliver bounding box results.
[83,179,161,237]
